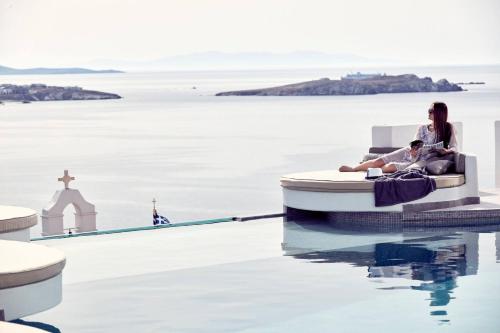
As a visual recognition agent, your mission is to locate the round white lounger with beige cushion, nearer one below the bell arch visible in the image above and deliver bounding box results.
[0,240,66,321]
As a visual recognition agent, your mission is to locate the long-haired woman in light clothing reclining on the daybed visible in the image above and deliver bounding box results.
[339,102,457,173]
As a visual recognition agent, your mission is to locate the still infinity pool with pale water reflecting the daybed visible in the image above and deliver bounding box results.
[18,219,500,333]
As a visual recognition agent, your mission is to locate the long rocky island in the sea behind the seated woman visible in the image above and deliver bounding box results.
[216,73,463,96]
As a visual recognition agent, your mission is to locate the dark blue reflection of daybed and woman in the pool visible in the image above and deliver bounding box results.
[282,215,500,323]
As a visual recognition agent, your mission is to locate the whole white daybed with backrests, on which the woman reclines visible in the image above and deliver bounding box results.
[281,123,479,222]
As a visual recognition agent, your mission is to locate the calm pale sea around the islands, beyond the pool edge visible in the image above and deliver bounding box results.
[0,66,500,234]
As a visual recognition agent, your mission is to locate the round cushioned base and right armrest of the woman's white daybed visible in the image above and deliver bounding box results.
[281,155,479,221]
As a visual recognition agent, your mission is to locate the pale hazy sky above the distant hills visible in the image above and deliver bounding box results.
[0,0,500,67]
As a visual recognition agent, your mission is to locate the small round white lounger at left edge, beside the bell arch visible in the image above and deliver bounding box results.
[0,206,38,242]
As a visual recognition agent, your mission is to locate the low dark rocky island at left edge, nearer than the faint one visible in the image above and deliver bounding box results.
[0,84,121,103]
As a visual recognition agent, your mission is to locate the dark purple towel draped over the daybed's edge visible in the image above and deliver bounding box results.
[375,169,436,207]
